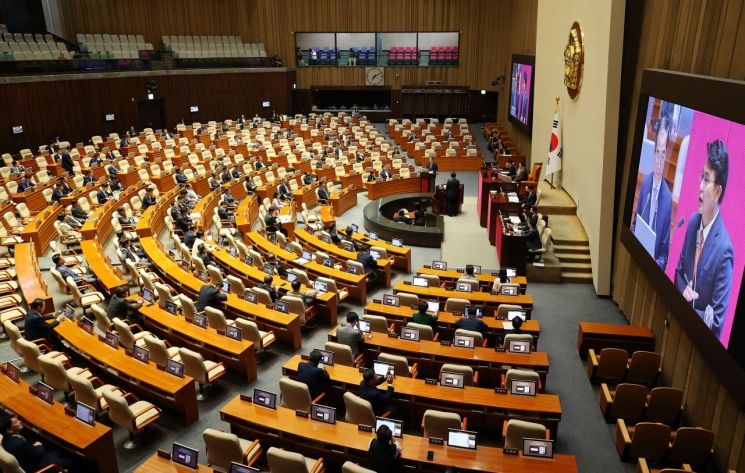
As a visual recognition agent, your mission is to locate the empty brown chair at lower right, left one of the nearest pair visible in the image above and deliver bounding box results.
[616,419,670,463]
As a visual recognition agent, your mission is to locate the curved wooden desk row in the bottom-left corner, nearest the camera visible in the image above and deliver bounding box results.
[0,373,119,473]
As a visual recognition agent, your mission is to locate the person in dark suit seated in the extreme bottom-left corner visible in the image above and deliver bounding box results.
[0,416,77,471]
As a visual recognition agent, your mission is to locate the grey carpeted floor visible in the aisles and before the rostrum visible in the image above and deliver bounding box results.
[0,125,633,473]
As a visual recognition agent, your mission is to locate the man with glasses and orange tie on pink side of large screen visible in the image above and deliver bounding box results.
[675,140,734,338]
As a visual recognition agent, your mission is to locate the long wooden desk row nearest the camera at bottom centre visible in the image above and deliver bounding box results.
[220,396,578,473]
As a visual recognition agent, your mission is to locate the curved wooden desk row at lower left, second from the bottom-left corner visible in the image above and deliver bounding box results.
[54,320,199,424]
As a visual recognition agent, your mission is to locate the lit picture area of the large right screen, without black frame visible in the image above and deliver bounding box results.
[631,97,745,348]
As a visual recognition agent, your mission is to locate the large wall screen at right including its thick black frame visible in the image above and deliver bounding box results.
[621,70,745,402]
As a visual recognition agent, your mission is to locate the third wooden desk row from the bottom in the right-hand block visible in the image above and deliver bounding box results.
[329,327,549,387]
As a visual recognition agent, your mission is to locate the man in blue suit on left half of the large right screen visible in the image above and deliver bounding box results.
[631,115,673,271]
